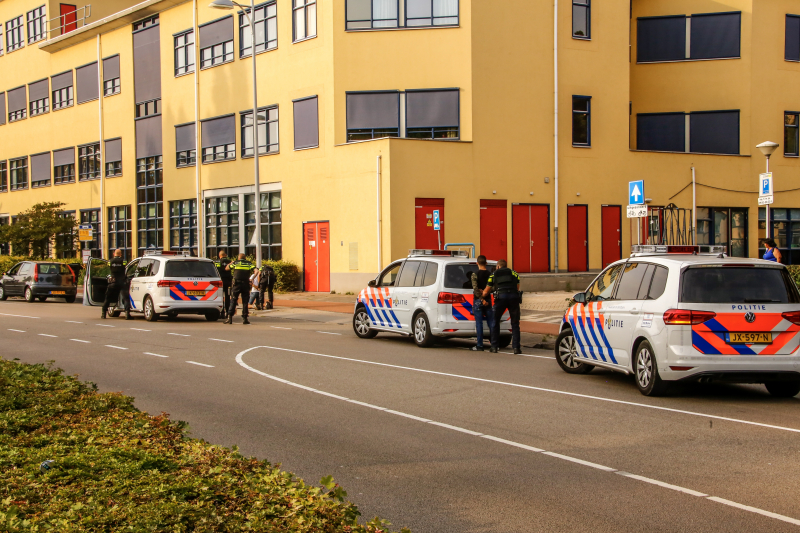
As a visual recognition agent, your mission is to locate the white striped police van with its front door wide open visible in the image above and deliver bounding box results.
[83,250,223,322]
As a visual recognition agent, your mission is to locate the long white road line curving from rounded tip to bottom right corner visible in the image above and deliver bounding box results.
[236,346,800,525]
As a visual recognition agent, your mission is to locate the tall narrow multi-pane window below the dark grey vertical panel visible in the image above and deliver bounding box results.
[136,155,164,255]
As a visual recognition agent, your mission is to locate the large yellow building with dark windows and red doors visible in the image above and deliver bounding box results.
[0,0,800,292]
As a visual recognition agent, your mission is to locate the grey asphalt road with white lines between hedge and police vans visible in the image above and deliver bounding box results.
[0,300,800,533]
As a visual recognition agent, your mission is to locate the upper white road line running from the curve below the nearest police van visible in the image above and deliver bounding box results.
[236,346,800,433]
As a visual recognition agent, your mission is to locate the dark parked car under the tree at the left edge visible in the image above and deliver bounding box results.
[0,261,80,303]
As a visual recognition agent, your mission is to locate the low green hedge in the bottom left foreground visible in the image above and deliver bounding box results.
[0,358,407,533]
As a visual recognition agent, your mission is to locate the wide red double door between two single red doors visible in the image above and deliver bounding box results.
[511,204,550,273]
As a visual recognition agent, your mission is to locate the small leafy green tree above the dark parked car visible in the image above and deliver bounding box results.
[0,202,77,259]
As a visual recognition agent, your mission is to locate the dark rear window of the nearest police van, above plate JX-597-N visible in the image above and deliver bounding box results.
[681,267,800,304]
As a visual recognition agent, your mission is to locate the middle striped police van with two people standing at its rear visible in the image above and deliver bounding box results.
[353,250,511,348]
